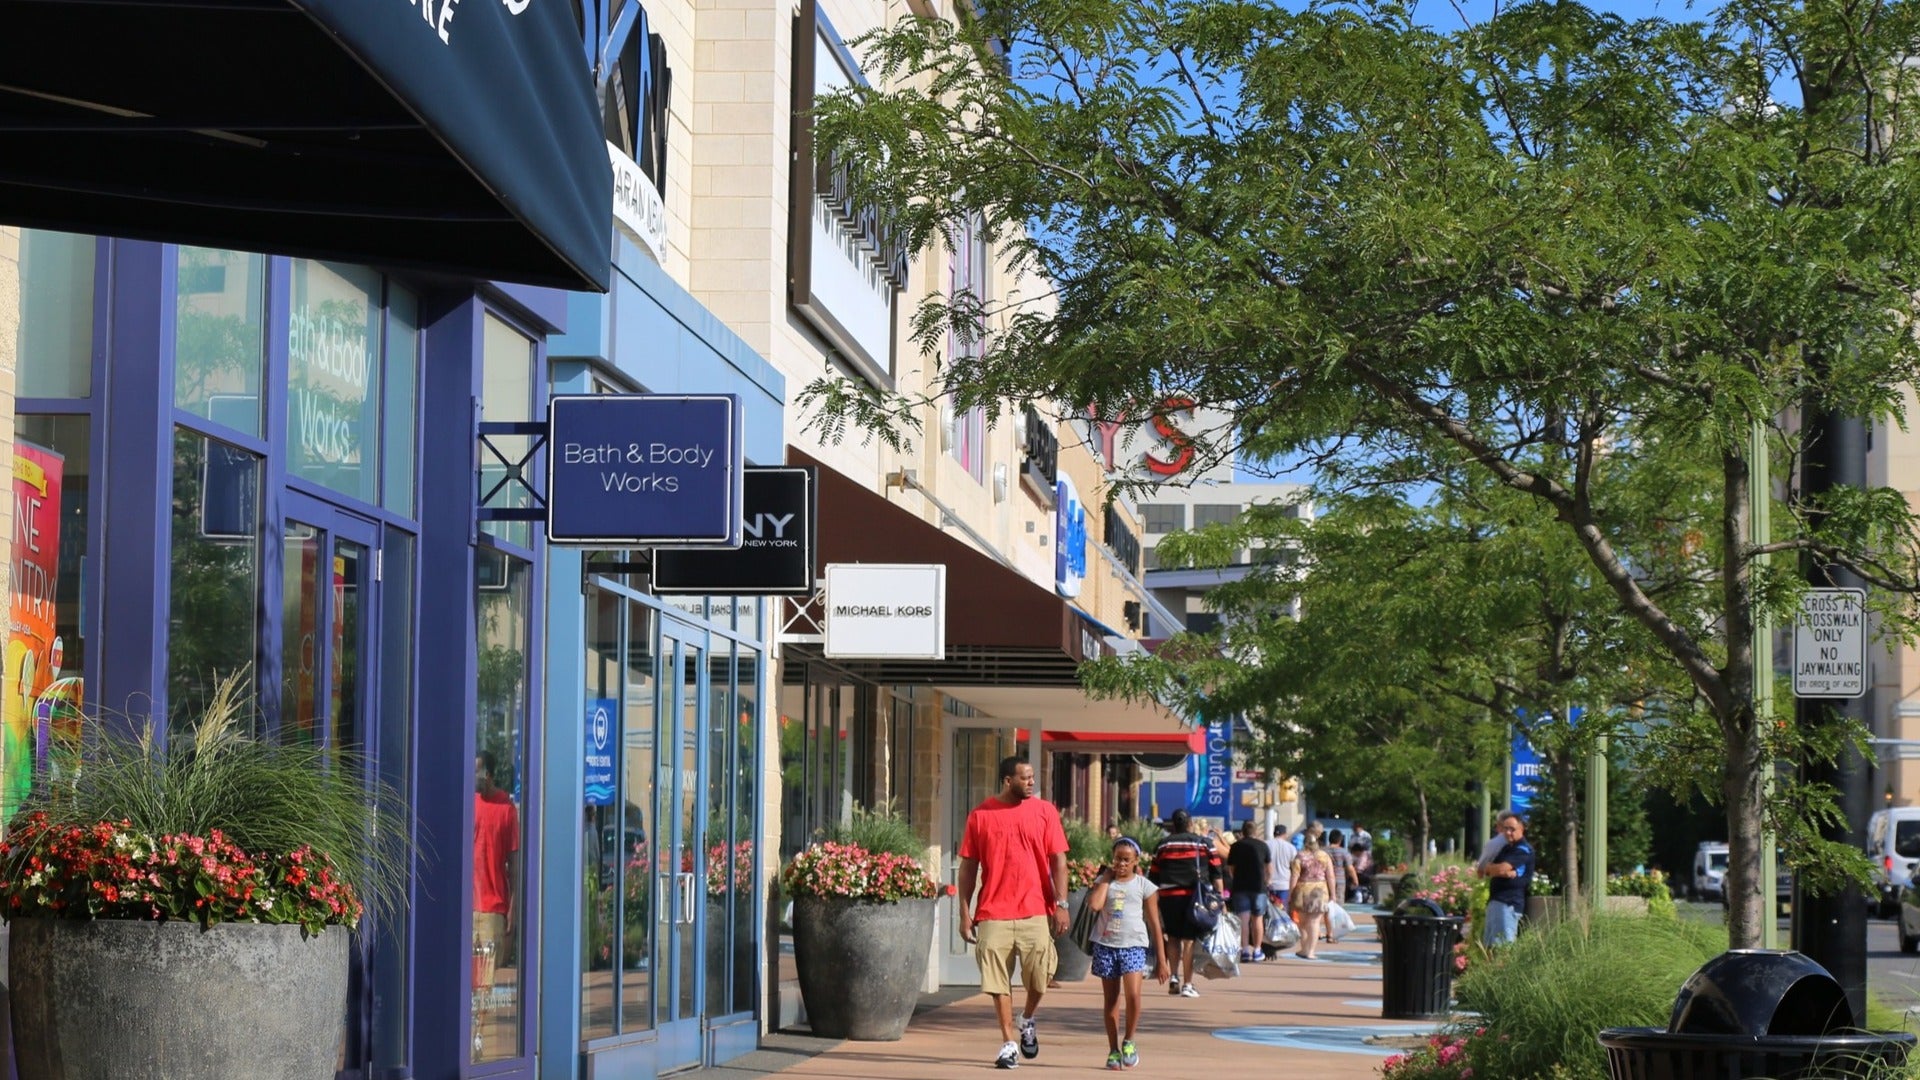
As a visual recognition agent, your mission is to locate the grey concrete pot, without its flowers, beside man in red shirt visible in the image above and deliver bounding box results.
[794,896,935,1037]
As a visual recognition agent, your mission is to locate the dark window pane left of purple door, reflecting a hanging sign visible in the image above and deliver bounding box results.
[167,429,261,728]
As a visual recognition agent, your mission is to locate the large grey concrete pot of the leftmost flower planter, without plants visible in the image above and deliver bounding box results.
[8,907,351,1080]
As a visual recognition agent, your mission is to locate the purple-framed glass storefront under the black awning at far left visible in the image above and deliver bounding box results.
[4,231,566,1076]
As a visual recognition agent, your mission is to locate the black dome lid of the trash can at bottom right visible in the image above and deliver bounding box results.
[1667,949,1853,1036]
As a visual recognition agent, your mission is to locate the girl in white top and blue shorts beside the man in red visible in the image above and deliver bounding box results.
[1087,836,1167,1068]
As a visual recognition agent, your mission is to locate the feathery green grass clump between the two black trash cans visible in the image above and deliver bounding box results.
[1450,913,1726,1080]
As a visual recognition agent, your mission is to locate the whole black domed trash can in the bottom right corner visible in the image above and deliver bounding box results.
[1599,949,1914,1080]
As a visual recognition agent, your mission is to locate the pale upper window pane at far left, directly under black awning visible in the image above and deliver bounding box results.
[15,229,98,398]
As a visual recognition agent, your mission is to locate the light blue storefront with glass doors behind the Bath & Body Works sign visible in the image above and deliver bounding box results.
[538,234,783,1076]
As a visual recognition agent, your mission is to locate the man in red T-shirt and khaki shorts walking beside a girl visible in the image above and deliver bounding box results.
[960,757,1068,1068]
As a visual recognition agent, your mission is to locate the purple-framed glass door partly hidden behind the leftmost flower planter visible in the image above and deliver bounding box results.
[273,492,403,1076]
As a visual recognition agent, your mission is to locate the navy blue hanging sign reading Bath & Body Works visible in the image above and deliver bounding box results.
[547,394,745,548]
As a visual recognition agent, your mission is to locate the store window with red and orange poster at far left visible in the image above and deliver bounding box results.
[0,415,92,821]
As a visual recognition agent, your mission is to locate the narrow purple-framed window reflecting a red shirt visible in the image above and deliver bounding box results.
[472,553,534,1063]
